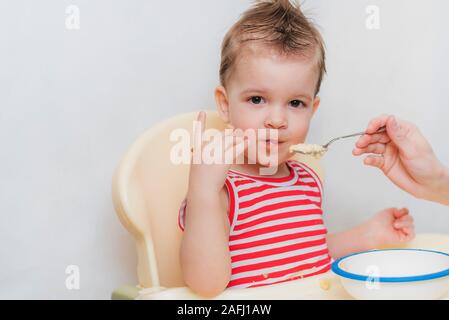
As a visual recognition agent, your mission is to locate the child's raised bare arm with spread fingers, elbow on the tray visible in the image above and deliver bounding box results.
[180,112,247,297]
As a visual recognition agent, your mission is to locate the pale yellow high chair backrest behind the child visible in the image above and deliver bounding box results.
[112,111,321,288]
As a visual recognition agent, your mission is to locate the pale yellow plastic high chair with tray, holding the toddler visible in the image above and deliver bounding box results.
[112,111,449,300]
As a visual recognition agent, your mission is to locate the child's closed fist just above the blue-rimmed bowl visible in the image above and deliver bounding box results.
[365,208,415,249]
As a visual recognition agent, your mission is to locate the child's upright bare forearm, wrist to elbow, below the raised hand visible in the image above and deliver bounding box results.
[181,186,231,297]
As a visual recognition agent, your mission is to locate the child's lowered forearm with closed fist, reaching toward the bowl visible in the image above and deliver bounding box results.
[327,208,415,259]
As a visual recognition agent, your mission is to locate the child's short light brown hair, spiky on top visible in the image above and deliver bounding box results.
[220,0,326,94]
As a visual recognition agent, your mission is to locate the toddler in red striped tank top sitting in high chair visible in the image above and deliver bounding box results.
[179,0,414,297]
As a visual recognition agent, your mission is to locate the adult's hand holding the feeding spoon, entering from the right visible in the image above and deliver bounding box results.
[352,115,449,205]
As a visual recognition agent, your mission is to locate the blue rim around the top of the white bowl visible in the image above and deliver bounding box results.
[332,249,449,282]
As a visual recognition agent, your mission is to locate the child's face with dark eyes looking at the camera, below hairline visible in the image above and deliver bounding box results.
[215,47,320,163]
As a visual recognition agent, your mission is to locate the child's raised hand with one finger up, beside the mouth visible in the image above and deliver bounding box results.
[189,111,248,193]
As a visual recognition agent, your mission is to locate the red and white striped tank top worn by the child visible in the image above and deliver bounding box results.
[178,160,331,288]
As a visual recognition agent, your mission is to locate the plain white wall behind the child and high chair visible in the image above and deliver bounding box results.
[0,0,449,299]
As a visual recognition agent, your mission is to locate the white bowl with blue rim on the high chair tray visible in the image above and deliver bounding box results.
[332,249,449,300]
